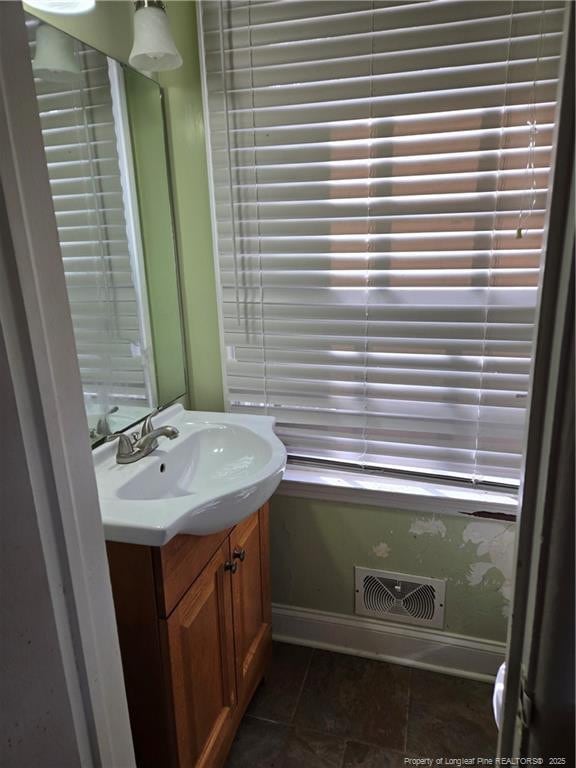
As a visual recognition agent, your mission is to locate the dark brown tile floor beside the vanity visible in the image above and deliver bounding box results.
[226,643,497,768]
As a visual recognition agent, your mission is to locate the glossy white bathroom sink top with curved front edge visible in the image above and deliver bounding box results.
[94,405,286,546]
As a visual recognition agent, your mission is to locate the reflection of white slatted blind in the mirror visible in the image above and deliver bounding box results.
[27,20,151,410]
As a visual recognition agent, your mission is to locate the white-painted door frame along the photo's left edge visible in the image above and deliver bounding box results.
[0,2,135,768]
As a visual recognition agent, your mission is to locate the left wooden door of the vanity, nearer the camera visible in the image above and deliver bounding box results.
[167,541,236,768]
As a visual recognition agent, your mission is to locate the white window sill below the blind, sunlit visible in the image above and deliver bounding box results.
[277,464,518,520]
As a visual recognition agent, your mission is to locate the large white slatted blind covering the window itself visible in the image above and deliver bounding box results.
[201,0,565,484]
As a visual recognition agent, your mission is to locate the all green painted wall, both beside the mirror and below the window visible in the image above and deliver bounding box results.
[25,1,514,640]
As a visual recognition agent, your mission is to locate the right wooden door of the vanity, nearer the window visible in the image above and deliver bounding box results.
[230,505,272,700]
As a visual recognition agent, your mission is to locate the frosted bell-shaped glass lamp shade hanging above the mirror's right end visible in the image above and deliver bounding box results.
[129,6,182,72]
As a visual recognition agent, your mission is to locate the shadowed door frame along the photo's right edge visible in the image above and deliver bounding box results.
[498,3,574,764]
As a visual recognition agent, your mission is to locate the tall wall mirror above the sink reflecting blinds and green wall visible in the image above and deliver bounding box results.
[26,14,187,445]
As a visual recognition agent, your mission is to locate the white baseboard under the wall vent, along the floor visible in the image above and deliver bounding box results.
[272,604,506,682]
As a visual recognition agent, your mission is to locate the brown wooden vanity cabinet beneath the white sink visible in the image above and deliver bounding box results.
[107,505,271,768]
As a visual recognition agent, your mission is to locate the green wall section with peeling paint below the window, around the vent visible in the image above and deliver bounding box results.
[271,496,515,641]
